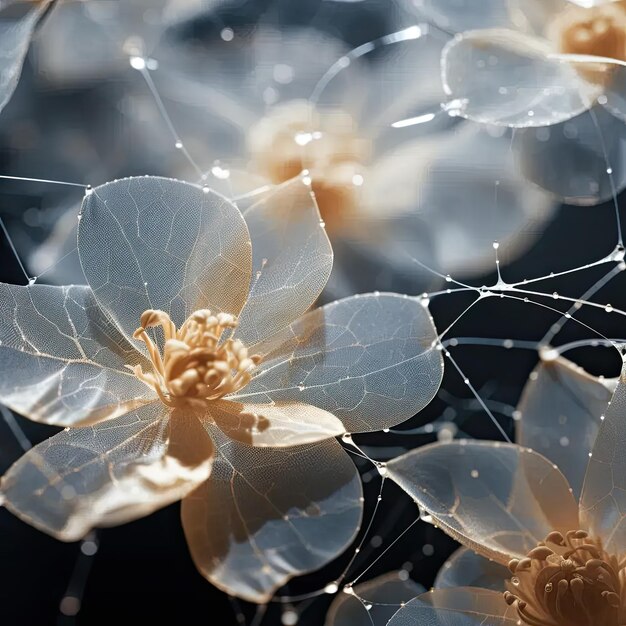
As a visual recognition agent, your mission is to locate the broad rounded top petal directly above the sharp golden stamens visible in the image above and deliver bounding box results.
[78,176,251,346]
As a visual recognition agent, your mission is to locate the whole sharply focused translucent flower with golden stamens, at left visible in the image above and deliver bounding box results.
[0,177,443,602]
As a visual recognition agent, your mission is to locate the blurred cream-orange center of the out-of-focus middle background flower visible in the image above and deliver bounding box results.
[248,100,370,232]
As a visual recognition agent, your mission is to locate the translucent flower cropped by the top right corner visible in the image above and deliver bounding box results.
[408,0,626,205]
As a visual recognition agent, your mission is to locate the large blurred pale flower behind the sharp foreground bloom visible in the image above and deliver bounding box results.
[153,20,554,297]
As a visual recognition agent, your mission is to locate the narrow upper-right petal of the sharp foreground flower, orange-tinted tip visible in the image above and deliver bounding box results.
[235,177,333,345]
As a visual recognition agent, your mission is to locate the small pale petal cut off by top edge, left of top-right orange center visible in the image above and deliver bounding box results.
[414,0,513,33]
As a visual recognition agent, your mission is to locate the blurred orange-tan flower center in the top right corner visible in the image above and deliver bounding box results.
[548,1,626,82]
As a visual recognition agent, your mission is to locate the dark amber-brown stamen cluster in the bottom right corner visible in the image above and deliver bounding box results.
[504,530,626,626]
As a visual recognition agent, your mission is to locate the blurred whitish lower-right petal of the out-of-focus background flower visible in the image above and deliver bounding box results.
[363,124,556,276]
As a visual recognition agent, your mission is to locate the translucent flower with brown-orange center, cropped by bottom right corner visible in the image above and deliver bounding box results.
[388,351,626,626]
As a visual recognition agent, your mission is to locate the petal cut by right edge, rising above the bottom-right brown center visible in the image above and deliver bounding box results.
[580,360,626,554]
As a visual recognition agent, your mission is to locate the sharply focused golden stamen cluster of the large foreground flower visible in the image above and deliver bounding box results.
[126,309,261,407]
